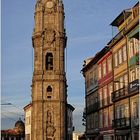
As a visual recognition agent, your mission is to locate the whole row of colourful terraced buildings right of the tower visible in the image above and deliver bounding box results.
[82,2,139,140]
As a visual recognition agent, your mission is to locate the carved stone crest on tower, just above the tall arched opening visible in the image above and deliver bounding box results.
[45,29,55,45]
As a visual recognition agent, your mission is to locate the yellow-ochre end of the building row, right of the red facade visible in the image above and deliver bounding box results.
[108,3,139,140]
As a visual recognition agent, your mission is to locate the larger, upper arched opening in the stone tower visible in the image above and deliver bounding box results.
[46,53,53,70]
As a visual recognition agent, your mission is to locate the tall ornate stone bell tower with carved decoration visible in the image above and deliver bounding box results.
[31,0,67,140]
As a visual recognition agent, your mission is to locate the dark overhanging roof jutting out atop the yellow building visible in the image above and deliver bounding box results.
[110,9,132,27]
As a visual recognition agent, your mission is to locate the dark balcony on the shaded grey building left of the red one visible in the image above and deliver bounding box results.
[86,102,99,114]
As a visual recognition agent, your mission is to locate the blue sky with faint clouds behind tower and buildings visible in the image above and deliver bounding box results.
[1,0,137,132]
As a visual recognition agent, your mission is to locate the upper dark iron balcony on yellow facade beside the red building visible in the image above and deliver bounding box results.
[112,87,128,101]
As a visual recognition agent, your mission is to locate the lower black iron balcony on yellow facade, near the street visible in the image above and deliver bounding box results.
[112,117,130,128]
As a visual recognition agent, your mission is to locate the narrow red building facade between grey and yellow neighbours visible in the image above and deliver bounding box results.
[97,47,114,140]
